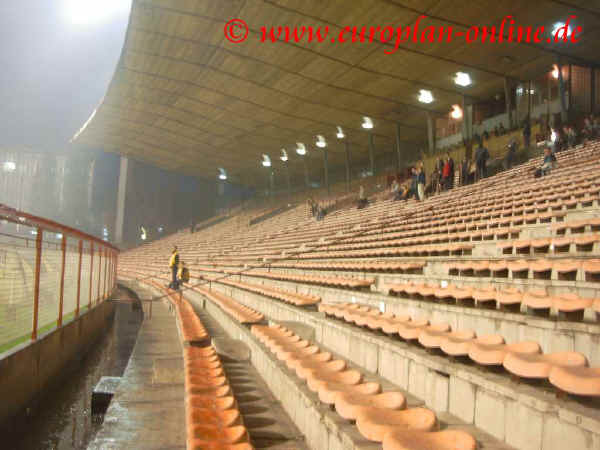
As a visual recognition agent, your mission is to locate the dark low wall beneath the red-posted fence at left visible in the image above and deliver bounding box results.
[0,301,114,426]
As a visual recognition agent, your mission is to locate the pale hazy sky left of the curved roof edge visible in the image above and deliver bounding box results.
[0,0,131,151]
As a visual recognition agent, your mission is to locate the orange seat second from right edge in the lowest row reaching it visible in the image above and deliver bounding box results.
[502,352,587,378]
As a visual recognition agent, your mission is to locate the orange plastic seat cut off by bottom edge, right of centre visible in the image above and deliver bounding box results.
[382,430,477,450]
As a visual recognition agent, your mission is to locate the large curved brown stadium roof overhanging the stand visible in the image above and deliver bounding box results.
[74,0,600,185]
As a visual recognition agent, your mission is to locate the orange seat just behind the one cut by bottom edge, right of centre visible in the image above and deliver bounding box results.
[355,406,437,442]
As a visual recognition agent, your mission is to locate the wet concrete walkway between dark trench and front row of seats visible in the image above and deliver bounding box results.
[88,301,186,450]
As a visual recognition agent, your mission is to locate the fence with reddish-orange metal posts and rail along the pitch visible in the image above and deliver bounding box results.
[0,205,119,354]
